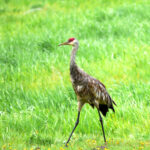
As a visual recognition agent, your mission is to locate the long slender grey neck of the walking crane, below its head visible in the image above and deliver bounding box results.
[70,43,79,74]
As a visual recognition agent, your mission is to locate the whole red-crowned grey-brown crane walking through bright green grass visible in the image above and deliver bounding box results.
[58,37,116,146]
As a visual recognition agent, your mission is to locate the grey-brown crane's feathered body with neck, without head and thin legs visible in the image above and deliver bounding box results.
[70,40,115,116]
